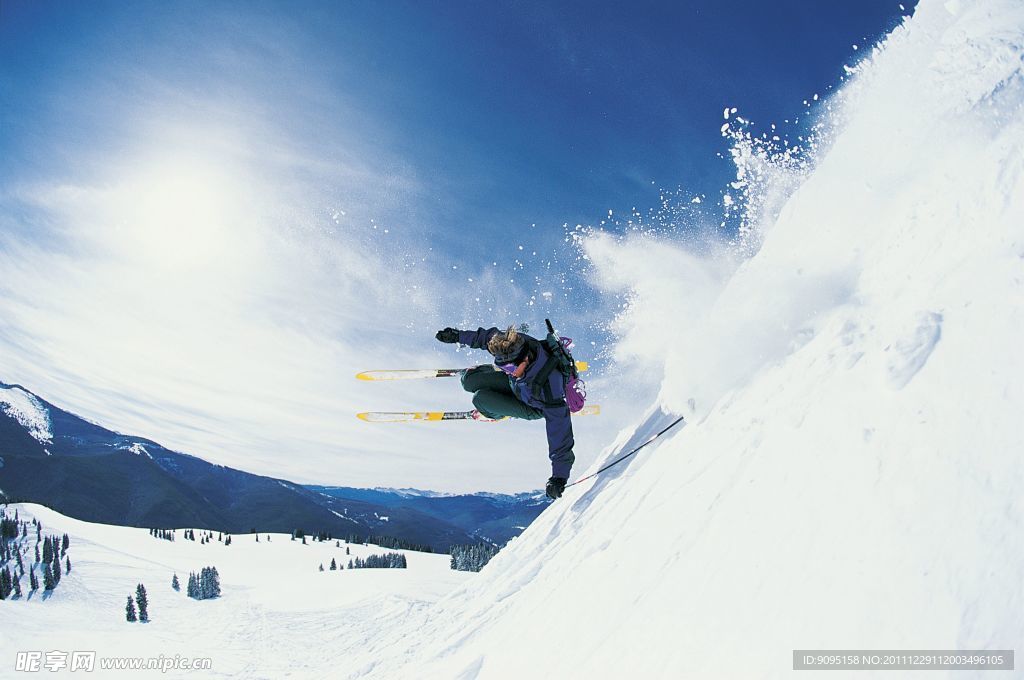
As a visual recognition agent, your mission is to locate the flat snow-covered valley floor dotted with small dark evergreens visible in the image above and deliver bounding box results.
[0,504,475,678]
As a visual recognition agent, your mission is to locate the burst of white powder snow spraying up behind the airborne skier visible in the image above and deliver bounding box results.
[578,91,831,415]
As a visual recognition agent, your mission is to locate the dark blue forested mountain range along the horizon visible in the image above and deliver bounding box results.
[0,382,547,551]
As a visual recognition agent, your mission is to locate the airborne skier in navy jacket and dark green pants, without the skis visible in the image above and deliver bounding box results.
[435,327,575,499]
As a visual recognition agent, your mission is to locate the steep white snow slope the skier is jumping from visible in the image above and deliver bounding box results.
[356,0,1024,679]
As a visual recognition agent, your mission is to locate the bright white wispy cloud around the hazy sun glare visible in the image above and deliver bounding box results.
[0,31,545,490]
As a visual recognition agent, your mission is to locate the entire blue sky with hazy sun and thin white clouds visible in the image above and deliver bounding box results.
[0,0,913,491]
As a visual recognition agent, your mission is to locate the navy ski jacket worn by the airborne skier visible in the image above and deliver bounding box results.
[459,328,575,479]
